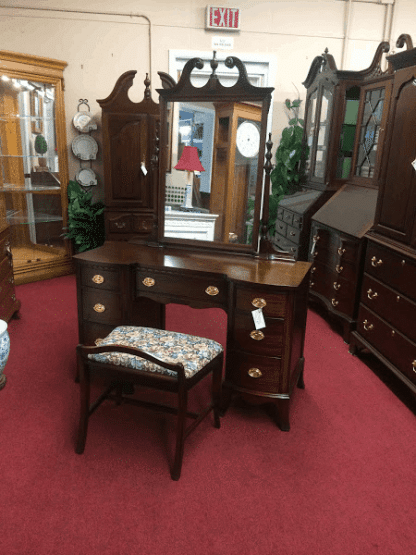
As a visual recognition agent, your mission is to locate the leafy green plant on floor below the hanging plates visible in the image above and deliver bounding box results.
[65,181,105,252]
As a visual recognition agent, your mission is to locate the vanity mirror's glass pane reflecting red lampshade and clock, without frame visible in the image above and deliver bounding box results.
[164,101,262,245]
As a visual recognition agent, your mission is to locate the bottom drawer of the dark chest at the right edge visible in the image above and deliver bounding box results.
[357,305,416,384]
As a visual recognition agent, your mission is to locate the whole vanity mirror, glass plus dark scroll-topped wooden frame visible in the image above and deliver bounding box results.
[157,52,273,253]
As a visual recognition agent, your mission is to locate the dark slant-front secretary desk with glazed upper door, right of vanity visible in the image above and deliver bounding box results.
[309,43,393,342]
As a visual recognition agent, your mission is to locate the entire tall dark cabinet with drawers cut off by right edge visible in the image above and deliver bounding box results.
[350,35,416,393]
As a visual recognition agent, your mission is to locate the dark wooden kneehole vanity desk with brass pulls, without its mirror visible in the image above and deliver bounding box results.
[75,241,310,431]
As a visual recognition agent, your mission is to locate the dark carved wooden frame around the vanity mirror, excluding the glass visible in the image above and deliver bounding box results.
[157,52,274,254]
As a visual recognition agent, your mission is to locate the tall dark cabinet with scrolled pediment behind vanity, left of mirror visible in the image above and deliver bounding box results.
[97,71,160,241]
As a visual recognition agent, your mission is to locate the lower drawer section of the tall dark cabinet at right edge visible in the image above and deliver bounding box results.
[350,239,416,392]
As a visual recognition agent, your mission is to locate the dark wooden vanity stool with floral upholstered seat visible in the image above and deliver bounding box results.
[75,326,224,480]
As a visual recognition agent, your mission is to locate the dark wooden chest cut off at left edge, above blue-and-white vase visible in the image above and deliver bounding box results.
[0,228,20,322]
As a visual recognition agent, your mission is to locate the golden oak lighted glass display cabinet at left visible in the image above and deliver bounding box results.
[0,51,73,284]
